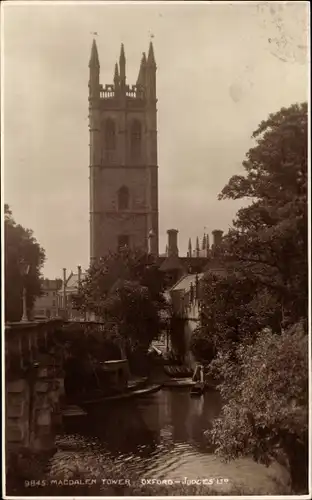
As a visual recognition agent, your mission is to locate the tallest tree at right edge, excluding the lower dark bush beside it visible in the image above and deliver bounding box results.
[220,103,308,324]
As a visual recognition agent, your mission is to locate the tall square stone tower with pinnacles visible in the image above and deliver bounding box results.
[89,40,158,261]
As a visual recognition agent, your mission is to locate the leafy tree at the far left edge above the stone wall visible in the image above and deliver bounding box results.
[4,205,45,321]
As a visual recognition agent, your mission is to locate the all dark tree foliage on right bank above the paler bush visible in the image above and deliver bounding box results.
[195,104,308,349]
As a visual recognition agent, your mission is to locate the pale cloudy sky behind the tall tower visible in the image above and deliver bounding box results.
[2,2,309,278]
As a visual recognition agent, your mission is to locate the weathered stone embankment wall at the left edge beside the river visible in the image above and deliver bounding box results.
[5,321,64,468]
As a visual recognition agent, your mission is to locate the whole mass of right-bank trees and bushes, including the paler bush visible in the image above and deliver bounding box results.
[192,103,308,493]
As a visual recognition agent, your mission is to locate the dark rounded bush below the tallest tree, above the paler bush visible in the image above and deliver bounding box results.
[196,270,282,358]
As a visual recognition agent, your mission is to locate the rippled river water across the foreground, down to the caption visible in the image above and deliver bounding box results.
[49,389,287,495]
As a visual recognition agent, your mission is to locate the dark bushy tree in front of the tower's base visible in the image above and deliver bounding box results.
[75,249,167,360]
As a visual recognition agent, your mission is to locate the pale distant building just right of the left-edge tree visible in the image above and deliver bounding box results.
[32,279,62,319]
